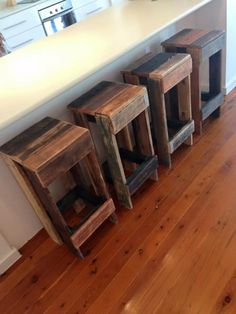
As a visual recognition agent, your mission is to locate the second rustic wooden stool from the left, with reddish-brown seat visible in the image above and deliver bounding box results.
[68,81,157,208]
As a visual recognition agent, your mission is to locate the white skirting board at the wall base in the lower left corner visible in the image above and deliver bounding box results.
[0,233,21,275]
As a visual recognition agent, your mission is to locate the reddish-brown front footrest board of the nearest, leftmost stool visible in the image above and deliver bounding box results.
[71,198,115,248]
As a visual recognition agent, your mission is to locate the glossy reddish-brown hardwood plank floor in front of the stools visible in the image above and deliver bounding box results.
[0,90,236,314]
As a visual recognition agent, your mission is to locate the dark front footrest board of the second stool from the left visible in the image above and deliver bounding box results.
[126,156,158,195]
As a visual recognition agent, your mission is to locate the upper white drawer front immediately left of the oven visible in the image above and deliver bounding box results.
[0,8,41,39]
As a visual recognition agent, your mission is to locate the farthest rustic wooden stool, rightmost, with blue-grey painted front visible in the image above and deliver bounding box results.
[162,29,225,134]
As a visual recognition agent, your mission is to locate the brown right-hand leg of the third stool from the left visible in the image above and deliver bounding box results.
[177,76,193,146]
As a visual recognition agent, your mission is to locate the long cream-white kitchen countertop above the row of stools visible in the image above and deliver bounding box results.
[0,0,213,129]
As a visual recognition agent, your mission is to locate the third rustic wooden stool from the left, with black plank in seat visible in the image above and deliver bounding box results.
[122,53,194,167]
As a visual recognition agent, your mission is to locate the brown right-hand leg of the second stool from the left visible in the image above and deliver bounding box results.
[133,108,158,181]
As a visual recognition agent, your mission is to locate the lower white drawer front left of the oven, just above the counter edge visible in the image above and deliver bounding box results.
[7,25,46,50]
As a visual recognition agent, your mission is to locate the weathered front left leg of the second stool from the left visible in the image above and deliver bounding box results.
[96,116,133,208]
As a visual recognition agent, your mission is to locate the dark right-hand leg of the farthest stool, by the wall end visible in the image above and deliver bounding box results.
[209,50,222,118]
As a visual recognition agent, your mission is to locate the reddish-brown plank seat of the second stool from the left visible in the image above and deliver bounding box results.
[71,81,148,133]
